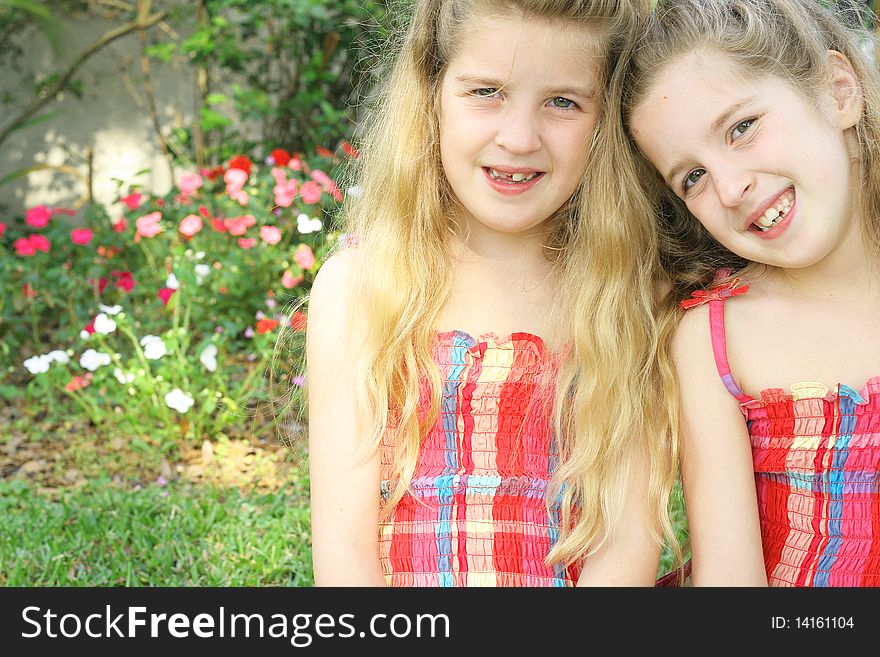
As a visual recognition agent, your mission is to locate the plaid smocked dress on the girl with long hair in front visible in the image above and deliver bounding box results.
[379,331,579,586]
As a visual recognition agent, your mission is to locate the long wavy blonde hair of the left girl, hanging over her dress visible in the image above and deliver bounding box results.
[326,0,674,563]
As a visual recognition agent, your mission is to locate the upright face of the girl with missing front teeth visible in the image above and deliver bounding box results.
[439,16,601,241]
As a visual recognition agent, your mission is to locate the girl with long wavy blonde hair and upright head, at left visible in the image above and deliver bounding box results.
[307,0,672,586]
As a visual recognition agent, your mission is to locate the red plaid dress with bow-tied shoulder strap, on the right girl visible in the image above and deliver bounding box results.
[682,272,880,586]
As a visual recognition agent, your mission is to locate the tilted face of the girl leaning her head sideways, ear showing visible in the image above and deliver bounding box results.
[630,51,861,268]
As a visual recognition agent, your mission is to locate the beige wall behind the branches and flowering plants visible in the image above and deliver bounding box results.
[0,20,193,218]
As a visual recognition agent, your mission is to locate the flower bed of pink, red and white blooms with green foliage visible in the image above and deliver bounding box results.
[0,144,357,441]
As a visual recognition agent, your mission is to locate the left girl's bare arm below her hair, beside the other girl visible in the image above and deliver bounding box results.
[578,452,660,586]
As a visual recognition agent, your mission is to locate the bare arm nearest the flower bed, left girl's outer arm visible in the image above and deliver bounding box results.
[306,254,385,586]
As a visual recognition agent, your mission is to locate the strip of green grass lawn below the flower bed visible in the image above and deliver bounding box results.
[0,481,313,586]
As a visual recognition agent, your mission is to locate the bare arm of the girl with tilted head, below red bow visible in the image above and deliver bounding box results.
[673,307,767,586]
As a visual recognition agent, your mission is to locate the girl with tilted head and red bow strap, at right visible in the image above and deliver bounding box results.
[624,0,880,586]
